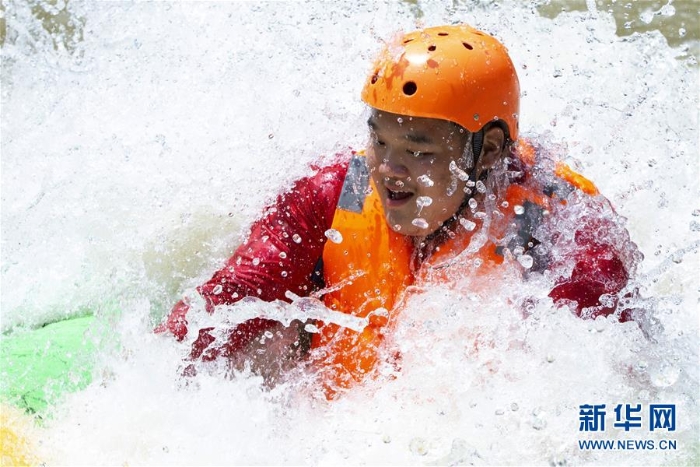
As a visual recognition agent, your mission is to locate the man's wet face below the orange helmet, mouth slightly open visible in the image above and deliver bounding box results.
[367,109,471,237]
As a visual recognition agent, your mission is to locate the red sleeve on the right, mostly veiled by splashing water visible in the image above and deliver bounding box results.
[549,215,634,322]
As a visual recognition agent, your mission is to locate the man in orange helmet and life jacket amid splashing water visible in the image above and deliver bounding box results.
[158,25,639,396]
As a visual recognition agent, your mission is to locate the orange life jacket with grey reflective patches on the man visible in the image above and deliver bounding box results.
[311,142,597,397]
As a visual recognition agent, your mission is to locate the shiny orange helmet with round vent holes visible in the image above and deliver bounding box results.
[362,25,520,141]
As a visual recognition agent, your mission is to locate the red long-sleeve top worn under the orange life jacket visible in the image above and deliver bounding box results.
[156,152,629,360]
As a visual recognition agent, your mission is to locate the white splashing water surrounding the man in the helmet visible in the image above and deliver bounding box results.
[1,2,700,465]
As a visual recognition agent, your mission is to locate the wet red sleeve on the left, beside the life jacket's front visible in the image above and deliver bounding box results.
[156,159,348,359]
